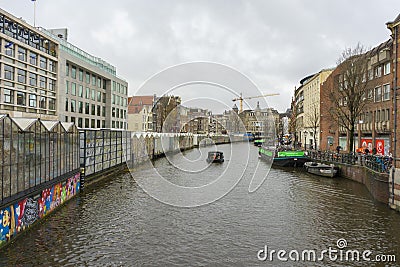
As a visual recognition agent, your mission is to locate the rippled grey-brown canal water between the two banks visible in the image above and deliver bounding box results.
[0,143,400,266]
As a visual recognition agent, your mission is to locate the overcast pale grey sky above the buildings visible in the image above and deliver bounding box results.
[0,0,400,112]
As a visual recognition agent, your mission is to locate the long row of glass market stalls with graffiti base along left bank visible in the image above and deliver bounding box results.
[0,115,243,247]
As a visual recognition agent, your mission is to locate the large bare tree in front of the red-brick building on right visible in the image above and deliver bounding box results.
[327,44,370,151]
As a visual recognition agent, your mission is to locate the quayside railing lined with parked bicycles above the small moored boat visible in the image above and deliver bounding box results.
[308,150,393,173]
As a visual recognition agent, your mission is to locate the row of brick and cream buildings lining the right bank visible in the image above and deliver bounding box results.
[291,15,400,209]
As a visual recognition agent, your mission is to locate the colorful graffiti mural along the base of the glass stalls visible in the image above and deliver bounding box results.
[0,173,80,246]
